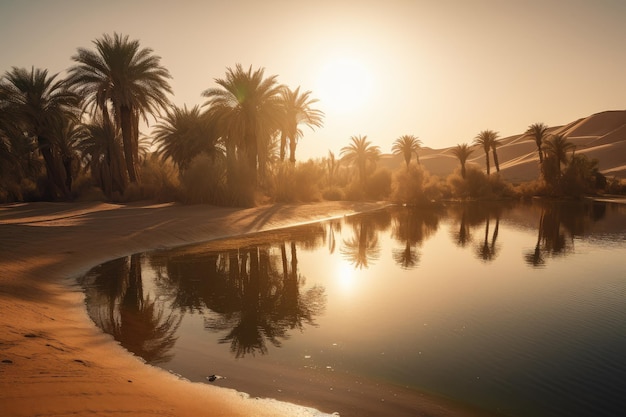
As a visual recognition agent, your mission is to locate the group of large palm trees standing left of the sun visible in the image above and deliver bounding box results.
[0,33,323,202]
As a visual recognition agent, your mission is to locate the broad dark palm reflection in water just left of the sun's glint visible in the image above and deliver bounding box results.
[193,242,324,357]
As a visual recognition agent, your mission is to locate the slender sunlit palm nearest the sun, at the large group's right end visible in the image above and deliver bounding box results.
[280,87,324,163]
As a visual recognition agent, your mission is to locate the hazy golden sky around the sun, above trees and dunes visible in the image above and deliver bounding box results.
[0,0,626,159]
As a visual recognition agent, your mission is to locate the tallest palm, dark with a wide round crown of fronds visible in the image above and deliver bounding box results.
[69,33,172,182]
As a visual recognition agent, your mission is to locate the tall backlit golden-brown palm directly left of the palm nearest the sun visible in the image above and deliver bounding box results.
[202,64,283,187]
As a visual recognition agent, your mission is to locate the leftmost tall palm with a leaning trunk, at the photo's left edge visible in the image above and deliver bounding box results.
[0,67,79,197]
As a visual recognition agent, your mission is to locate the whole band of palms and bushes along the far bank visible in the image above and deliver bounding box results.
[0,33,624,206]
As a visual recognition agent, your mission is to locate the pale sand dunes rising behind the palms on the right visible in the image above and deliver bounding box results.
[381,110,626,182]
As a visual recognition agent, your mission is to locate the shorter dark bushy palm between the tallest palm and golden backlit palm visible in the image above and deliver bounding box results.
[153,106,224,172]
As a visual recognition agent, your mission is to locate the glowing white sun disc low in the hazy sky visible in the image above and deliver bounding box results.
[318,58,372,113]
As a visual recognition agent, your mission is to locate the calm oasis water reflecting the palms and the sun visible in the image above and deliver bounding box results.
[82,202,626,417]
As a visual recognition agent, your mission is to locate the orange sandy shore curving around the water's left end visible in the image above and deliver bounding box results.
[0,202,498,417]
